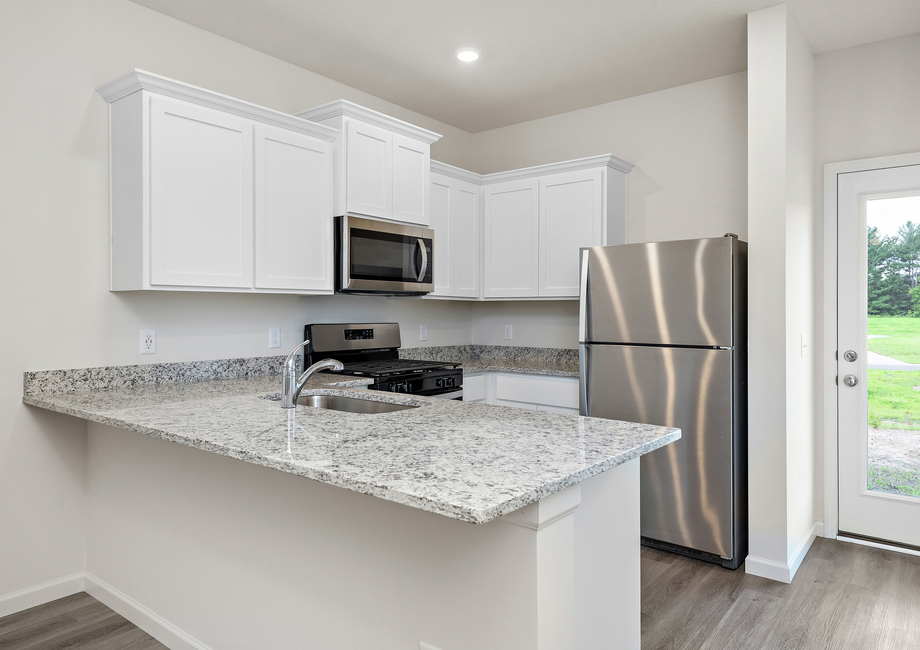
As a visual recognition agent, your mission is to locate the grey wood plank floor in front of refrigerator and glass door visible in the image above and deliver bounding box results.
[642,538,920,650]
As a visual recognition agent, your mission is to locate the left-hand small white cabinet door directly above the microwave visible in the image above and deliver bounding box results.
[345,120,393,219]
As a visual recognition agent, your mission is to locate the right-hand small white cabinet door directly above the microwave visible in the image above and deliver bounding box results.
[393,134,431,226]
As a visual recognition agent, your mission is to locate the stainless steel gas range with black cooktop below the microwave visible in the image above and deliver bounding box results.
[304,323,463,400]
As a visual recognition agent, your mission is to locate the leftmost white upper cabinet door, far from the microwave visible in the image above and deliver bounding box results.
[150,96,253,288]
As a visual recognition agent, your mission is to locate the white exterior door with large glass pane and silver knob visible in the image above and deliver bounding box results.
[837,165,920,547]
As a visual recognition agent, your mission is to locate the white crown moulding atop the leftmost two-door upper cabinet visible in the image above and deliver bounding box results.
[96,69,339,142]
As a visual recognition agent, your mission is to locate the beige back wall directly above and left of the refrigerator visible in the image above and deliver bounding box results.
[473,73,747,348]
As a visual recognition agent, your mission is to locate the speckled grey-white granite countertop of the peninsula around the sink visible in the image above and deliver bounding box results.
[23,357,680,523]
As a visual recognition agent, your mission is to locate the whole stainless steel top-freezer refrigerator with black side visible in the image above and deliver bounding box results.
[579,235,748,569]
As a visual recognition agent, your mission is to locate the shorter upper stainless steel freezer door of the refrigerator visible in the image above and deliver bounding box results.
[579,237,741,347]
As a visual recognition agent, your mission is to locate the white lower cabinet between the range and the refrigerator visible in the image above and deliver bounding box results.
[463,372,579,415]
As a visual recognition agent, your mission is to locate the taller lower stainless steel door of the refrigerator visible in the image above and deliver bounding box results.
[581,345,734,557]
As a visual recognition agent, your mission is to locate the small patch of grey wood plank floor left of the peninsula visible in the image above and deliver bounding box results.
[0,593,166,650]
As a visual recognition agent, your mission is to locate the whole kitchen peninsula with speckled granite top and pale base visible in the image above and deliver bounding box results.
[23,357,680,650]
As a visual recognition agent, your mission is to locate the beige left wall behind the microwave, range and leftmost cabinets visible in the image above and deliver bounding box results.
[0,0,471,611]
